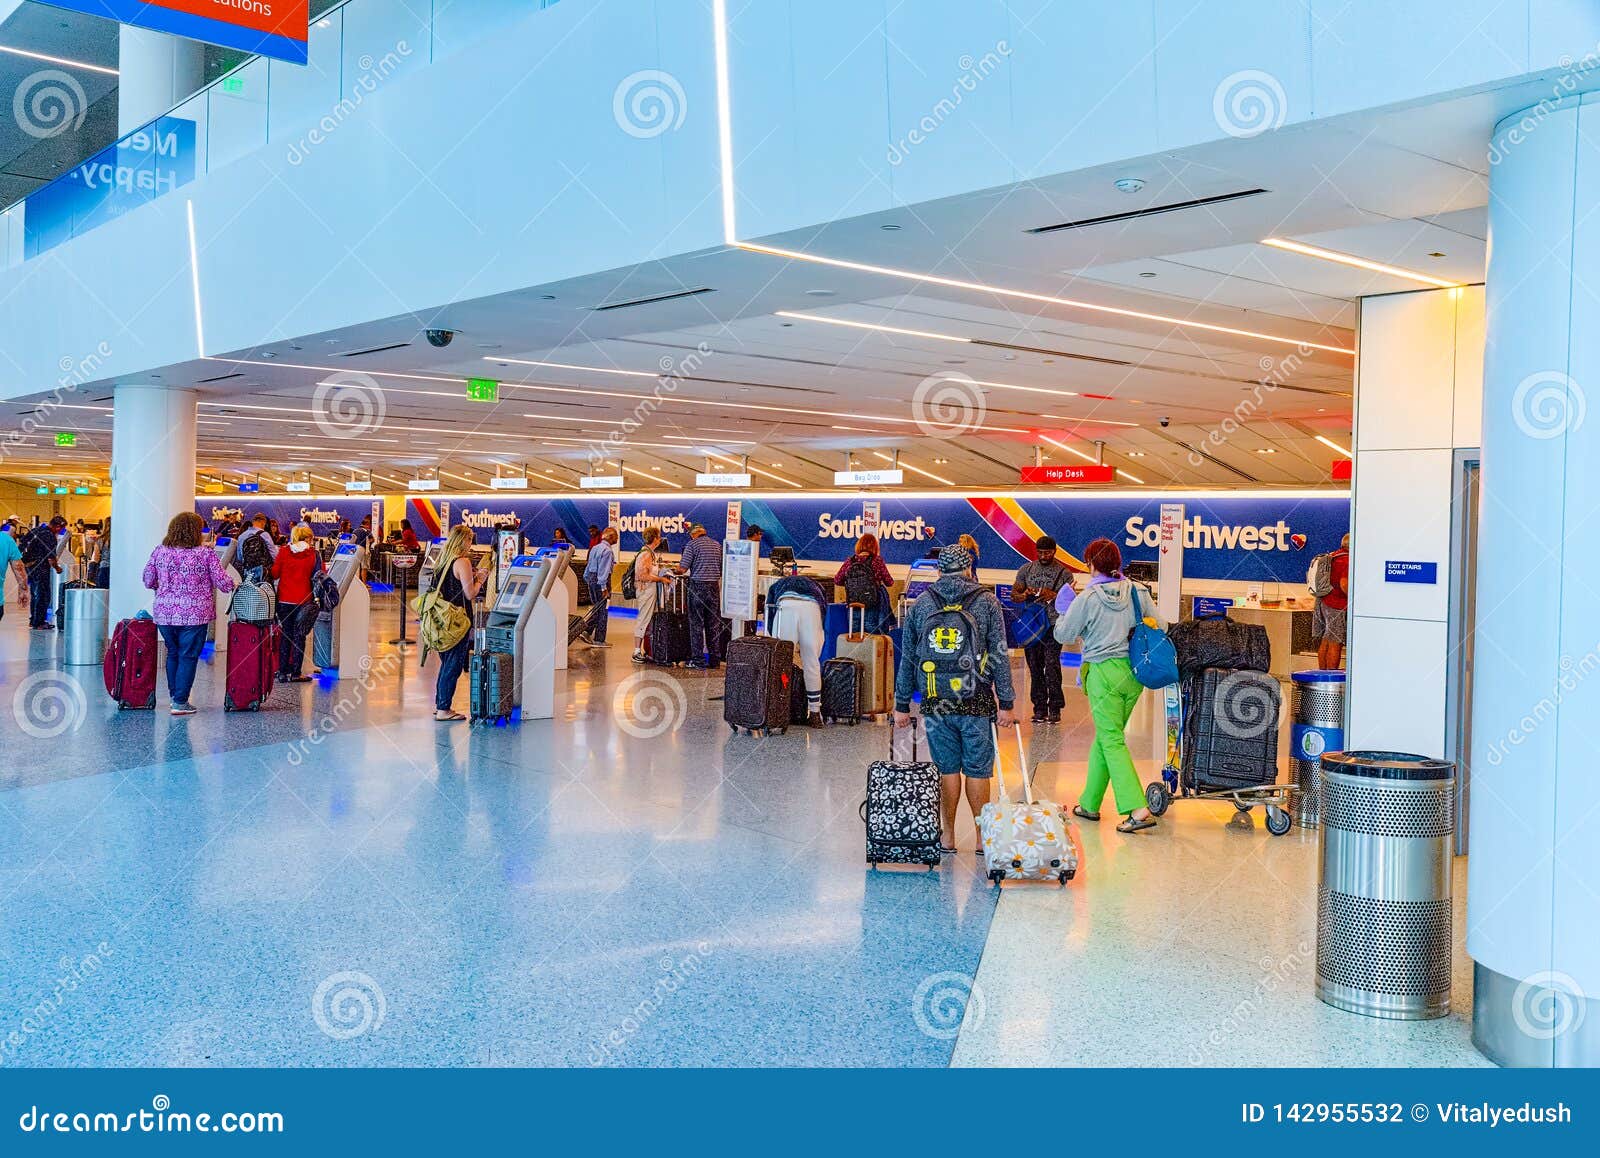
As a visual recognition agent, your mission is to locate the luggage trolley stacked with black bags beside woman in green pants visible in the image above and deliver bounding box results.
[1144,604,1294,837]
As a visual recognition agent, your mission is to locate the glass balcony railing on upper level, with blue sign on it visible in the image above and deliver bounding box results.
[0,0,557,270]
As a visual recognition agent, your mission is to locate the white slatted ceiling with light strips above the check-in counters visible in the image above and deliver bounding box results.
[0,96,1499,491]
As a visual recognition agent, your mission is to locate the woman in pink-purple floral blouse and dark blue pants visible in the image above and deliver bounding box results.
[144,510,234,715]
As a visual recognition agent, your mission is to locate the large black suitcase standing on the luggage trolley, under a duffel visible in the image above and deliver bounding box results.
[1182,667,1283,790]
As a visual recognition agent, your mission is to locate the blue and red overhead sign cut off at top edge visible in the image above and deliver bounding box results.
[45,0,310,64]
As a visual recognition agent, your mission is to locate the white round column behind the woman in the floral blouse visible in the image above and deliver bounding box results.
[110,385,195,624]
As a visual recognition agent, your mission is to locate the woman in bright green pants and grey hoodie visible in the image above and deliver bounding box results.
[1056,539,1155,832]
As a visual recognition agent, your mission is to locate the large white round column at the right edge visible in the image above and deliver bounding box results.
[1467,98,1600,1065]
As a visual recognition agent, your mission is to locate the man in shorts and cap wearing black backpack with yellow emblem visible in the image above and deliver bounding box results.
[894,545,1016,853]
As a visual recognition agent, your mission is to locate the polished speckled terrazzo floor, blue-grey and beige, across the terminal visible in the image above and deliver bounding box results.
[0,608,1478,1065]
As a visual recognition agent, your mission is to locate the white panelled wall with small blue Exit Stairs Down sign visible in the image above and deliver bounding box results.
[1347,286,1483,757]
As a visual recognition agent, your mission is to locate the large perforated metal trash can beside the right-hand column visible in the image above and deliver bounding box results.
[1317,752,1456,1020]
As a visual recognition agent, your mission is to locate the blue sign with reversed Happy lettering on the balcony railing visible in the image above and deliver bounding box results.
[22,117,195,258]
